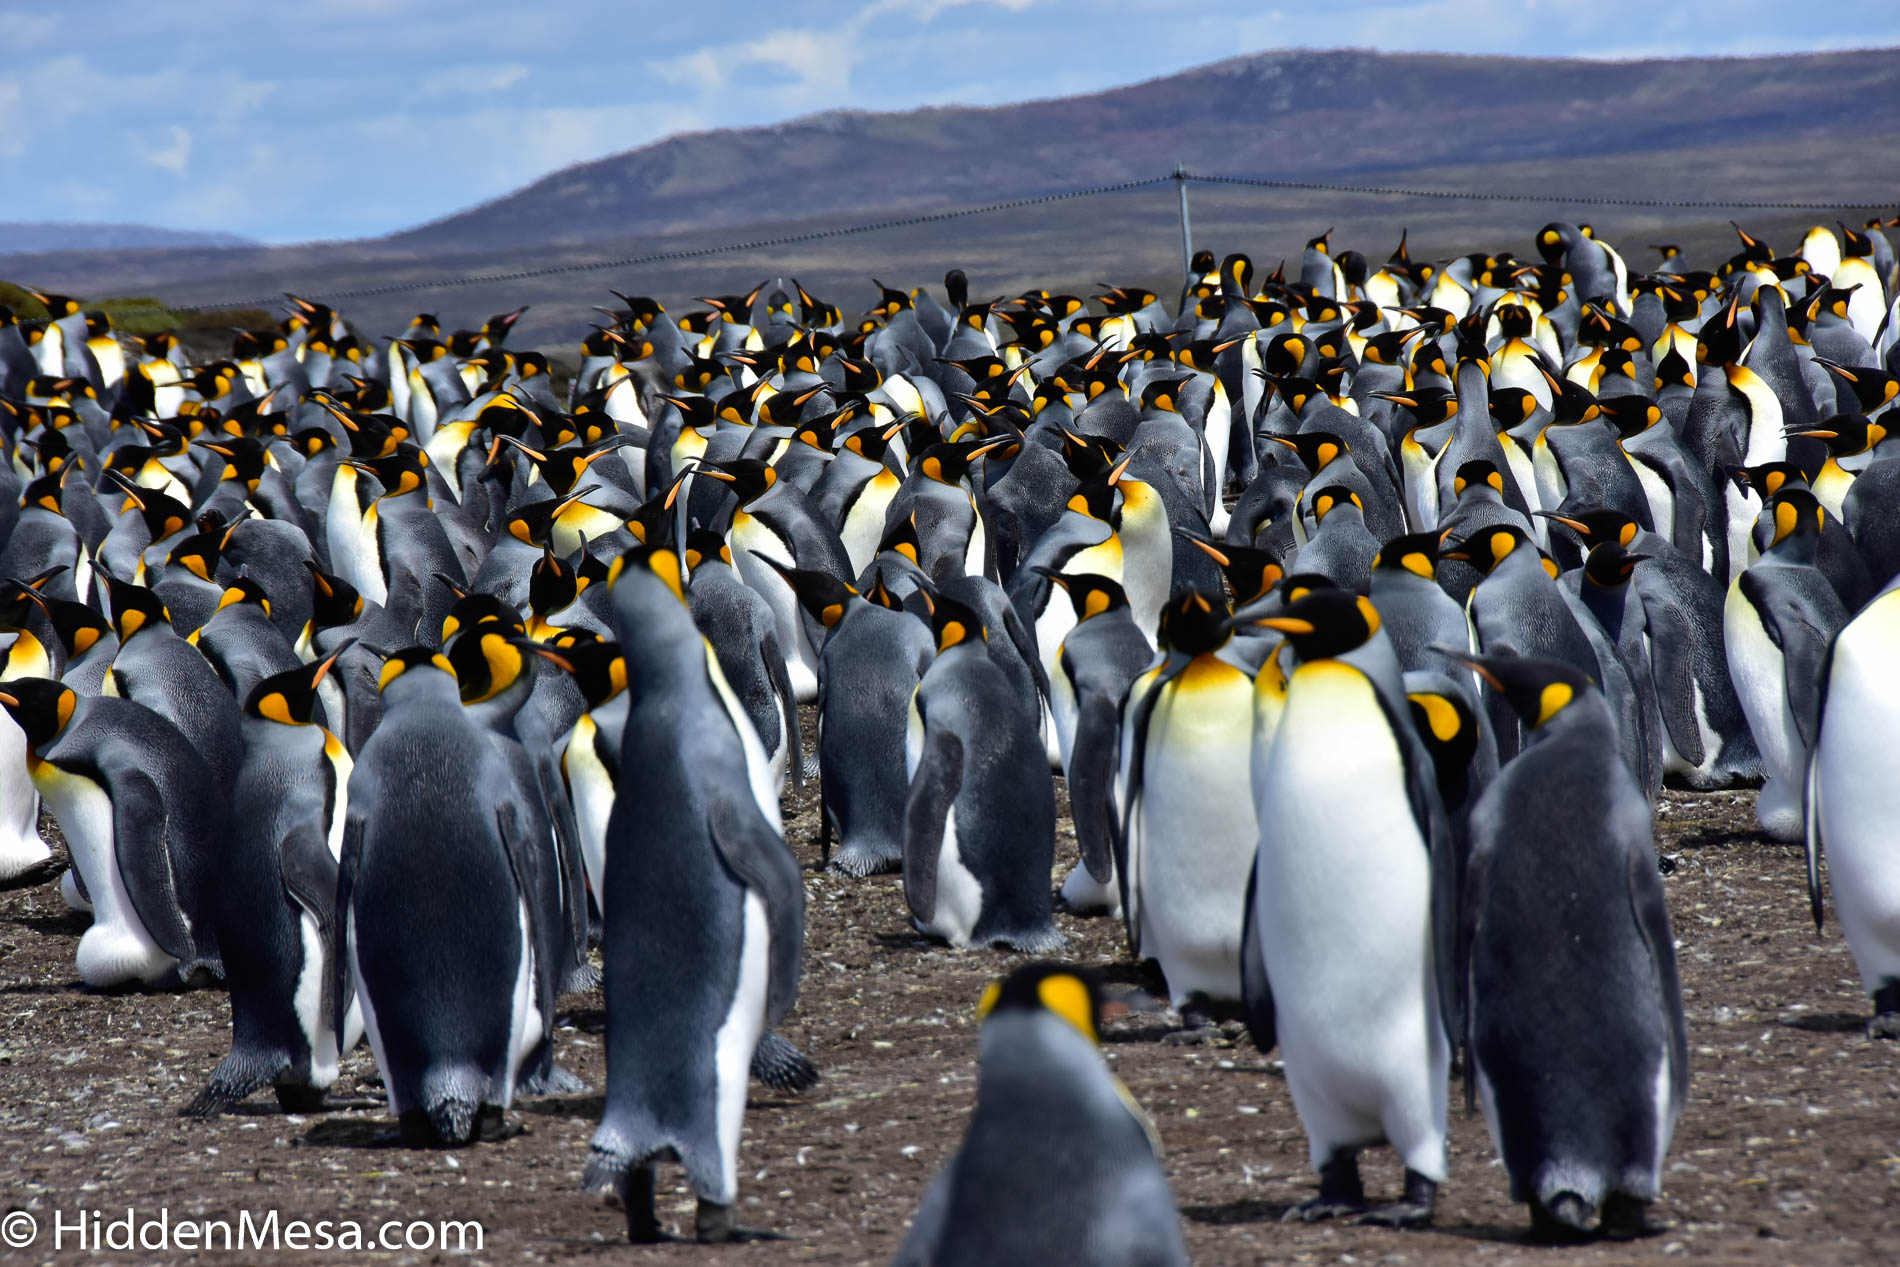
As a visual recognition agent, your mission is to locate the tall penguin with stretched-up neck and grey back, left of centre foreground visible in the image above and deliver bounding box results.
[581,545,804,1242]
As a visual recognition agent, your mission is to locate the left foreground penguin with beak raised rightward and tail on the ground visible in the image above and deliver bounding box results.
[184,644,363,1117]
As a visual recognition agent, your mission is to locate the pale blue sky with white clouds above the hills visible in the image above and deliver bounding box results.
[0,0,1900,241]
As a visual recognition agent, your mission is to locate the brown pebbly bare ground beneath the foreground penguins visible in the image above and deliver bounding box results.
[0,759,1900,1265]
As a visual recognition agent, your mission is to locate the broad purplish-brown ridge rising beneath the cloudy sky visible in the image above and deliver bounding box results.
[382,49,1900,251]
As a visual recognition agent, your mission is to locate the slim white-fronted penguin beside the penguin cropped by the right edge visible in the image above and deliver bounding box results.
[1721,488,1847,842]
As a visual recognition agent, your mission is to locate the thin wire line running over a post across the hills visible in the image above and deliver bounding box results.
[81,167,1900,315]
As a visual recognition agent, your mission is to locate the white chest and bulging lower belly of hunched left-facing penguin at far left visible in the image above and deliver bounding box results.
[32,762,179,988]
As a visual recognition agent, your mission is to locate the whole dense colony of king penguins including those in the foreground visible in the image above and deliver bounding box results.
[0,206,1900,1263]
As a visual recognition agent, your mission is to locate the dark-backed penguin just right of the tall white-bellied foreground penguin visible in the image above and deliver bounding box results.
[1459,655,1689,1237]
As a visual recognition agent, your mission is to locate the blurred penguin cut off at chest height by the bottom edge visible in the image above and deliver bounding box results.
[891,963,1188,1267]
